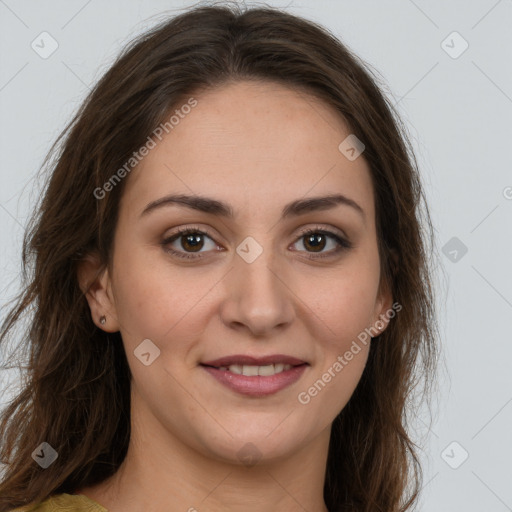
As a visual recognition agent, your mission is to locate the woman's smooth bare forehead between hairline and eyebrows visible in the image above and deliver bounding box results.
[122,81,374,224]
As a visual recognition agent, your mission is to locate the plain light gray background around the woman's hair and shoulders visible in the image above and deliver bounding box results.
[0,0,512,512]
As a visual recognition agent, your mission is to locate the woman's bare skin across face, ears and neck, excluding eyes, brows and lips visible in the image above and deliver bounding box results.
[77,81,392,512]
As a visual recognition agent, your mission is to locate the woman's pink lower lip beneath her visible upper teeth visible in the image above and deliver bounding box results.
[201,364,307,396]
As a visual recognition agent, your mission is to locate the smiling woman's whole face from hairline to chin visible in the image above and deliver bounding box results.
[90,81,391,463]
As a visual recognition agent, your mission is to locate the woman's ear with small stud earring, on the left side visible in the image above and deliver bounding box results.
[77,254,119,332]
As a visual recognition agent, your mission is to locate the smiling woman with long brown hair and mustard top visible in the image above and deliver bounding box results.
[0,6,437,512]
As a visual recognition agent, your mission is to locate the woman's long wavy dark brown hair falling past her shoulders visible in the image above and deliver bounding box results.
[0,5,439,512]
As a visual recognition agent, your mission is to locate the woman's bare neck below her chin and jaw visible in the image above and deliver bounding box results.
[77,392,330,512]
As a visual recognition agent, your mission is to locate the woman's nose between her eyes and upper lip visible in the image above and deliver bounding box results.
[220,242,295,337]
